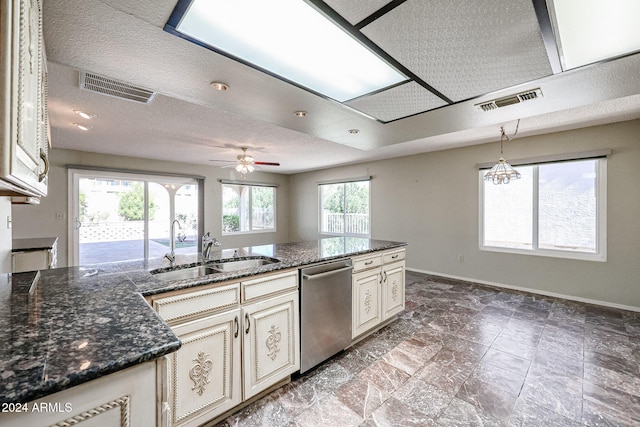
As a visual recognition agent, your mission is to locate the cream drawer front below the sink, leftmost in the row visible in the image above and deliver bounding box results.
[153,283,240,322]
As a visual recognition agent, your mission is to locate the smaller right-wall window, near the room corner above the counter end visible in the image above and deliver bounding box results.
[319,180,371,237]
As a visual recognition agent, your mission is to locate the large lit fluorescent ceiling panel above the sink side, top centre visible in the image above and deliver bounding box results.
[175,0,407,102]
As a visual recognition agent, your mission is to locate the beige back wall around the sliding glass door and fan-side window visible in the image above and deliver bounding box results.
[11,149,289,267]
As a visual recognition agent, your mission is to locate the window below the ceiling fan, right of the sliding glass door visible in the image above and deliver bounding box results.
[222,184,276,234]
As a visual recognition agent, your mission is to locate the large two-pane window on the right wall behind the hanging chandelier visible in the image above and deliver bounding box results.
[480,158,606,261]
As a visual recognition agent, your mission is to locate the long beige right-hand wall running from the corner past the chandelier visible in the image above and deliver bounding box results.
[290,120,640,307]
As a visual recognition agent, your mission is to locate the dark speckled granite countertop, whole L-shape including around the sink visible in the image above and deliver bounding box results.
[0,237,406,403]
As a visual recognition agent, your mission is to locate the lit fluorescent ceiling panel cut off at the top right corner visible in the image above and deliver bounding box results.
[553,0,640,70]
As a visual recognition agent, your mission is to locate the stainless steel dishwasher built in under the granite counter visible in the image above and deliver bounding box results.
[300,259,353,373]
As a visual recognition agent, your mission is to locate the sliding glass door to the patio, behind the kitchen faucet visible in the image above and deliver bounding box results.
[69,169,202,265]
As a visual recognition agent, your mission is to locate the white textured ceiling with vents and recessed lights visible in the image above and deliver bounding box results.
[43,0,640,173]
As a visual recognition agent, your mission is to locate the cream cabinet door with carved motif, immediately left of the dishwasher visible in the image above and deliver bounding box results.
[243,292,300,399]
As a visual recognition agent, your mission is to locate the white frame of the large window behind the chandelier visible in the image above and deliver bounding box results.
[478,156,607,262]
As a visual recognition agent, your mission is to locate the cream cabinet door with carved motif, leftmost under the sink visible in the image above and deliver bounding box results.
[167,309,242,426]
